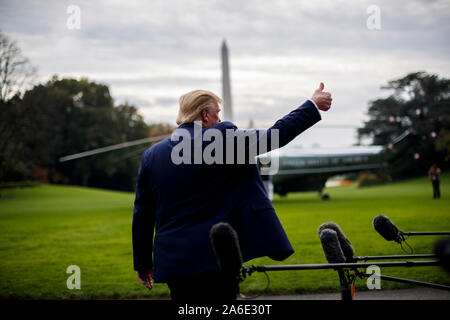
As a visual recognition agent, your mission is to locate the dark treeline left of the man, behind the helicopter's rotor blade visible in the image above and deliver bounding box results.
[0,76,174,191]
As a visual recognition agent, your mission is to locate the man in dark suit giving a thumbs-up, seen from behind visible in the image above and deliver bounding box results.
[132,83,332,301]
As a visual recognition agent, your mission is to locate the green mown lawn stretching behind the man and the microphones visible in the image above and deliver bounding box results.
[0,174,450,299]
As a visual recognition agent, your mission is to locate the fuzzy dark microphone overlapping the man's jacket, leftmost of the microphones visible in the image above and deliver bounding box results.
[209,222,242,277]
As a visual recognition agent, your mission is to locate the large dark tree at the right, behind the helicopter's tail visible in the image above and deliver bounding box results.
[358,72,450,177]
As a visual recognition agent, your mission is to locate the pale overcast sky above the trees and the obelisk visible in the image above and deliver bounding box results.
[0,0,450,147]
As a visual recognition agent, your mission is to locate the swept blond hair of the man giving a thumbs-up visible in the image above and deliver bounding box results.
[177,90,222,125]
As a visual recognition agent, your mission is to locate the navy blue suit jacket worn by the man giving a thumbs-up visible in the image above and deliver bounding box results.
[132,100,321,282]
